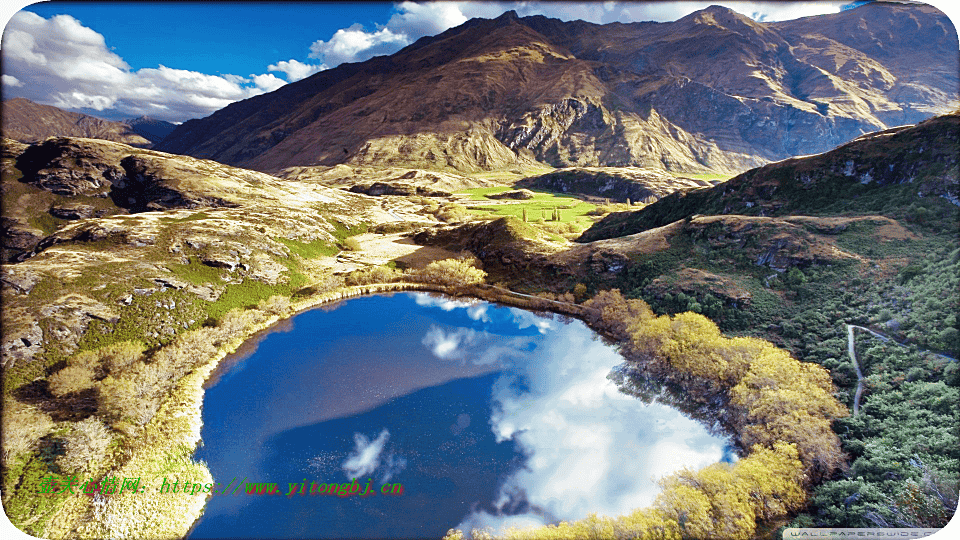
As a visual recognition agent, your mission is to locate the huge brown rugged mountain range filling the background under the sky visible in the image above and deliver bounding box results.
[158,3,960,173]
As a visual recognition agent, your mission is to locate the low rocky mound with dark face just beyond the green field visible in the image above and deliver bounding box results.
[516,167,713,203]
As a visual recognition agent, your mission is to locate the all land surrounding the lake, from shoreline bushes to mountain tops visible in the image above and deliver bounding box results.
[0,3,960,540]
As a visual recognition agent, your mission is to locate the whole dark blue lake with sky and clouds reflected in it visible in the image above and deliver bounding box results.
[190,293,731,539]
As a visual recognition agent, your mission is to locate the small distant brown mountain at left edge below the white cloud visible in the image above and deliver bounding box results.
[3,98,154,148]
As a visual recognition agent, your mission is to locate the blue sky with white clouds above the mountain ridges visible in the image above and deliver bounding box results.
[0,0,952,122]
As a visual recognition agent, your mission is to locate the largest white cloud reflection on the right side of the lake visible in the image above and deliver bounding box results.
[457,323,725,530]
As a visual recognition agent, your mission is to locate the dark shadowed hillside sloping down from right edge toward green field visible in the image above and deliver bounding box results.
[579,112,960,242]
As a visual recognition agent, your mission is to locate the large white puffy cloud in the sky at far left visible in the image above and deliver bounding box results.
[2,11,285,122]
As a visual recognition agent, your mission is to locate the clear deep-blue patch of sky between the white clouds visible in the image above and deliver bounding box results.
[26,2,393,75]
